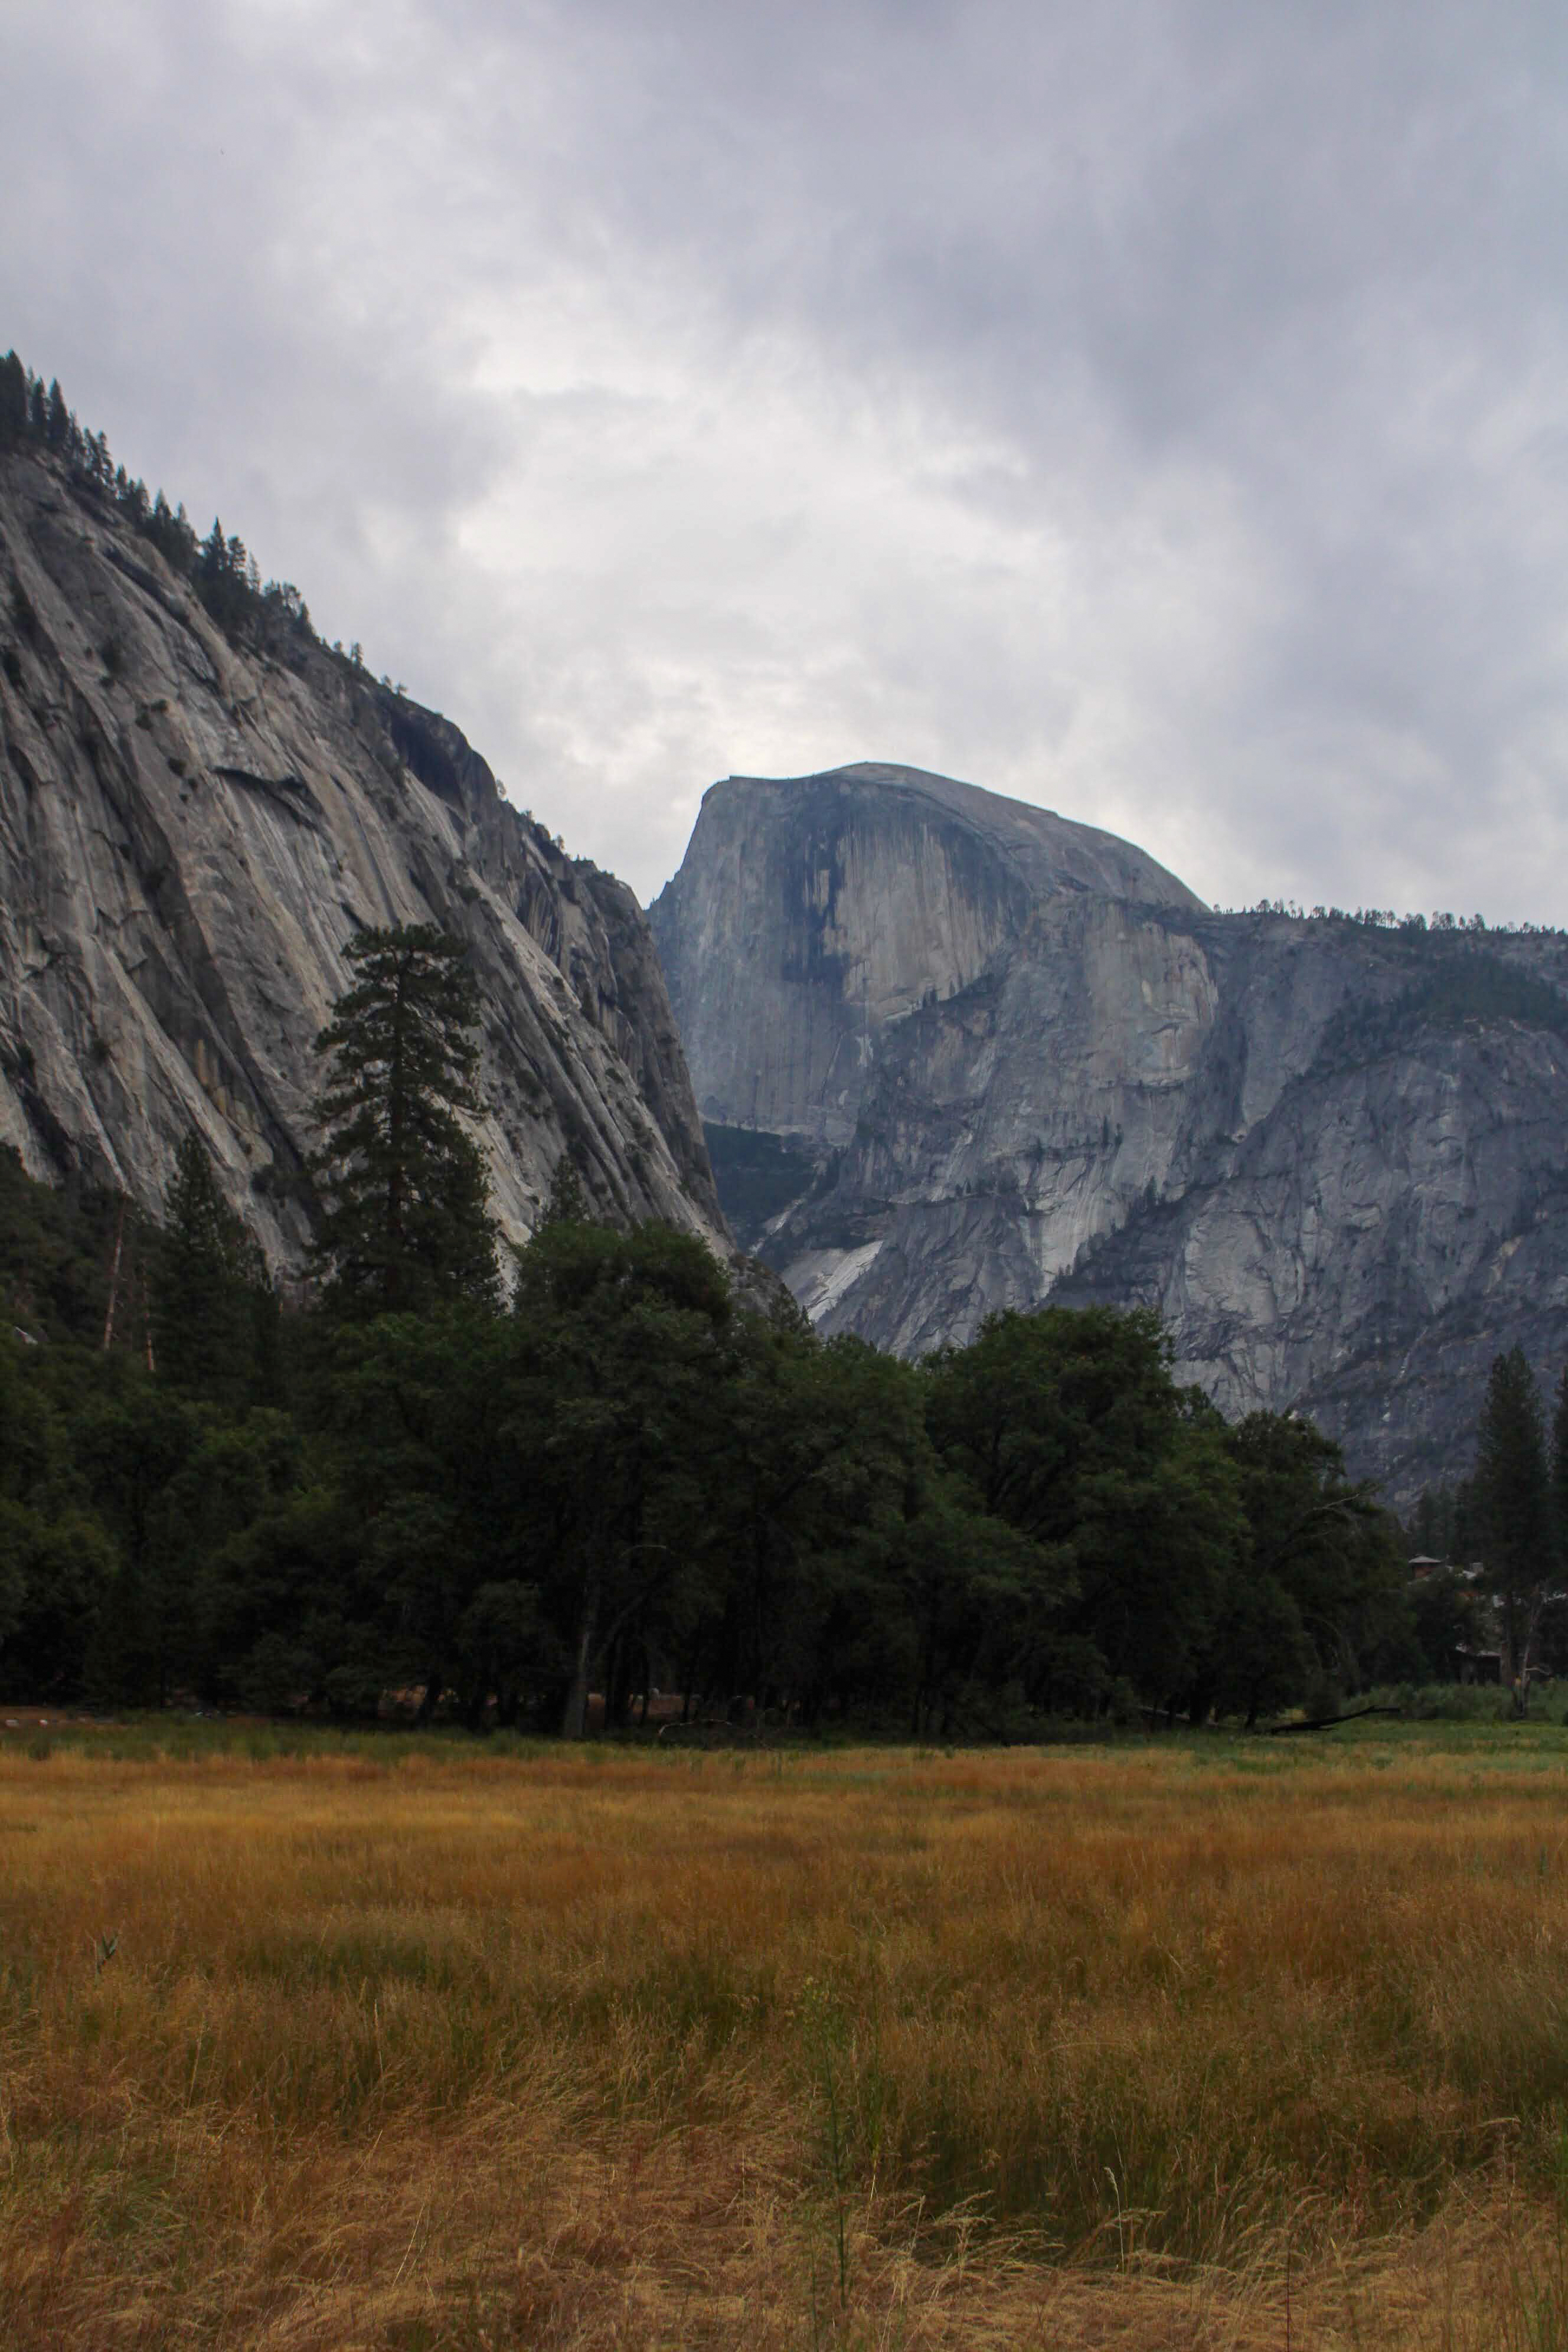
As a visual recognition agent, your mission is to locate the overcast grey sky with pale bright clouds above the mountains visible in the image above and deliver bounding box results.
[0,0,1568,922]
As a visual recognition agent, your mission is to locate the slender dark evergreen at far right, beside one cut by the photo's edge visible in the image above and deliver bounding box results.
[1474,1348,1554,1710]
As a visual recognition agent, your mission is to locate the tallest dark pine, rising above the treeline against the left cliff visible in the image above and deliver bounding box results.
[313,925,496,1315]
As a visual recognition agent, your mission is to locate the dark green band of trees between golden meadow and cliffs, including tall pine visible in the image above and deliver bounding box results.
[0,929,1432,1736]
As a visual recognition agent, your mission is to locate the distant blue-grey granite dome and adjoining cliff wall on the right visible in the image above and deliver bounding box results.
[654,769,1568,1503]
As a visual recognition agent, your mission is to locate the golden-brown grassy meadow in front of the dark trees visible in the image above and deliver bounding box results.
[0,1726,1568,2352]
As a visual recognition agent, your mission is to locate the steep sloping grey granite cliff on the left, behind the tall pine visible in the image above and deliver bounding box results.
[0,449,726,1265]
